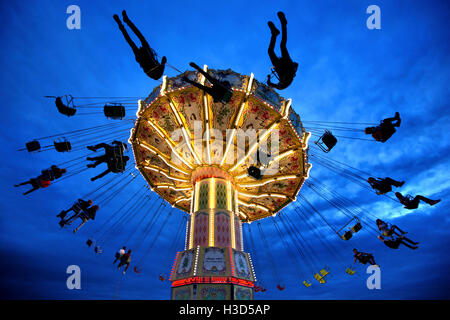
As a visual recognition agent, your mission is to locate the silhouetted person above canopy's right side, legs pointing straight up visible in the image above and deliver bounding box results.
[267,11,298,90]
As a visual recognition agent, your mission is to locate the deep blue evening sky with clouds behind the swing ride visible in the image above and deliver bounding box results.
[0,0,450,299]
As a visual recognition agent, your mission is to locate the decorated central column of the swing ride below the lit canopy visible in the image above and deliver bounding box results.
[169,167,256,300]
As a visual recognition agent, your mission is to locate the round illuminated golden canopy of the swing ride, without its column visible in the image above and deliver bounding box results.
[129,66,311,222]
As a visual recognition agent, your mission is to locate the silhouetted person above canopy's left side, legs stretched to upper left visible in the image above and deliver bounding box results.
[113,10,167,80]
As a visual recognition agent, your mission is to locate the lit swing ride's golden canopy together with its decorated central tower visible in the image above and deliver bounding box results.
[129,66,312,300]
